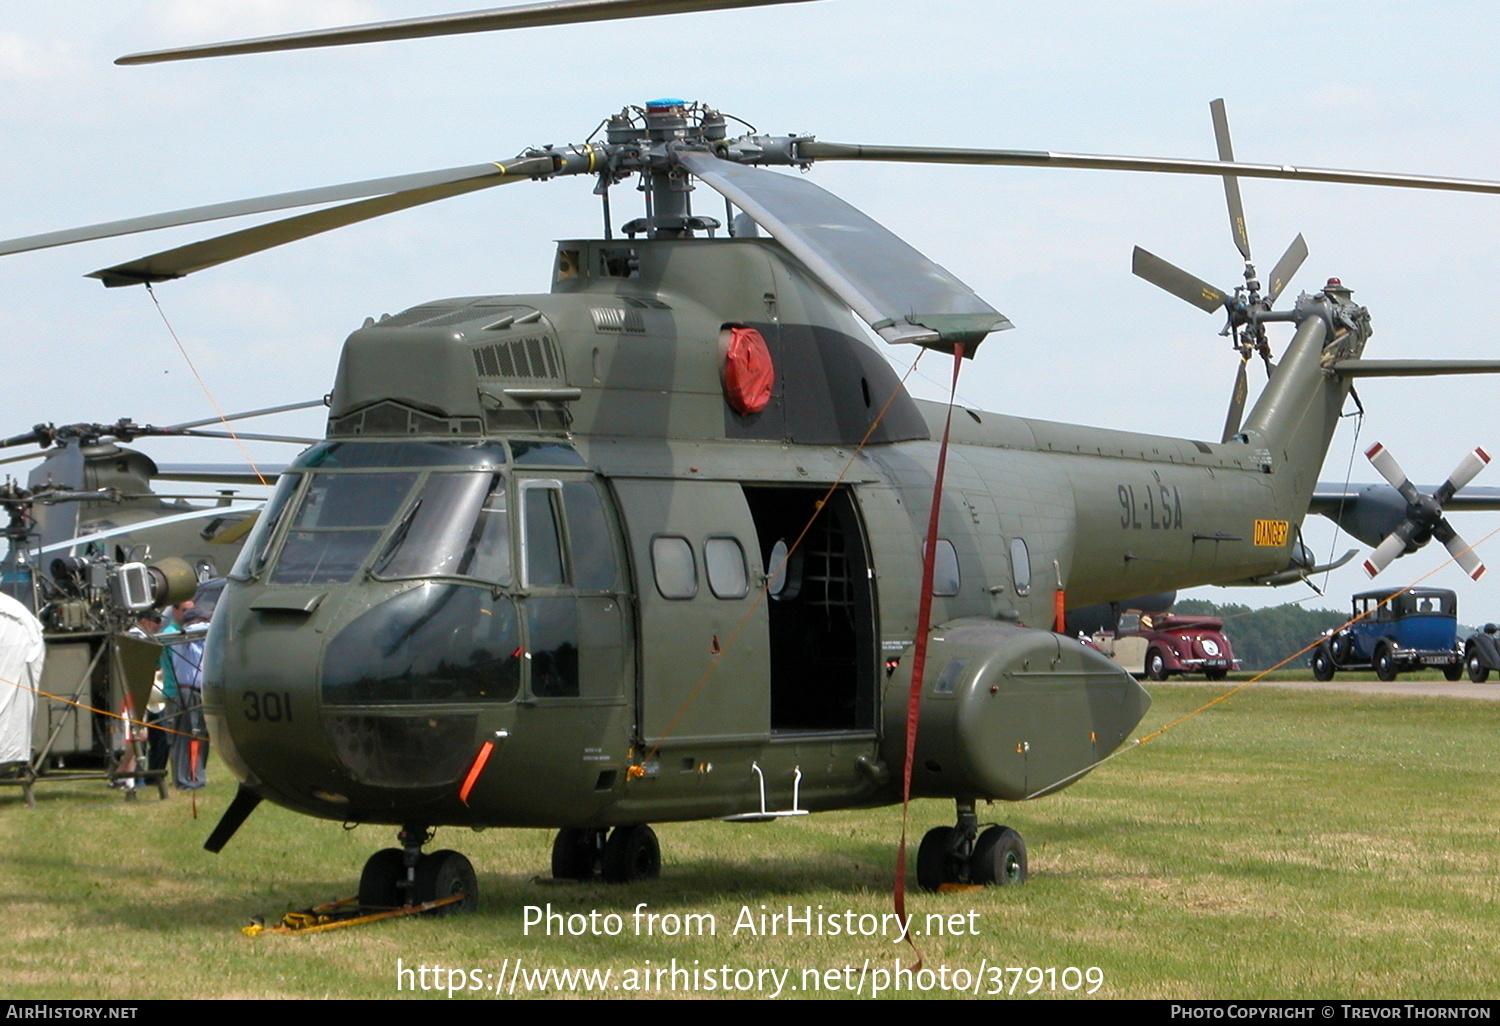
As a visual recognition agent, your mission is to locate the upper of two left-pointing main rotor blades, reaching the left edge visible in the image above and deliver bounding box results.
[0,162,540,257]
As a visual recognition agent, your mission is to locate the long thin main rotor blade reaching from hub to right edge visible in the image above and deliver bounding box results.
[797,140,1500,201]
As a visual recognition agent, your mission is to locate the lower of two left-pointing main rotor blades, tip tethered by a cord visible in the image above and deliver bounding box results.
[89,158,552,288]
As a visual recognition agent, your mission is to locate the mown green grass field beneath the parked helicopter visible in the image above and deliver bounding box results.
[0,686,1500,999]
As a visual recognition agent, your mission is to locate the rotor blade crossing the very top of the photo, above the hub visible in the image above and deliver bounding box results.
[114,0,806,65]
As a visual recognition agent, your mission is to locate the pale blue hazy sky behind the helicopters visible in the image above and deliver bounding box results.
[0,0,1500,621]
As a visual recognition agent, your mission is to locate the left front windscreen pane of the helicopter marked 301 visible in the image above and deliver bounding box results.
[270,473,417,585]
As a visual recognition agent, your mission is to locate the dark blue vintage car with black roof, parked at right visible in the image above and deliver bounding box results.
[1311,588,1464,681]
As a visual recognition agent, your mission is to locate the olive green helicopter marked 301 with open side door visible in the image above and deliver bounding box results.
[0,0,1500,905]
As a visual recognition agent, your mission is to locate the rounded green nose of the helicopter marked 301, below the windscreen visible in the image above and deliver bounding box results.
[206,582,519,819]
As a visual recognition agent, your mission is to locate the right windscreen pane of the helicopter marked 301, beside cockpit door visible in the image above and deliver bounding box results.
[372,473,510,584]
